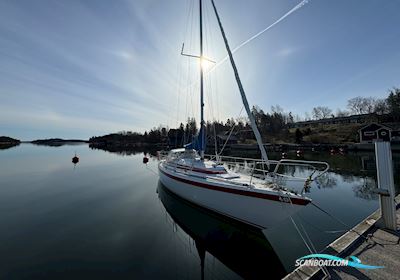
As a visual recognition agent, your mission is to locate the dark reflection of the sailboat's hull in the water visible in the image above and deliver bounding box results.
[157,182,286,279]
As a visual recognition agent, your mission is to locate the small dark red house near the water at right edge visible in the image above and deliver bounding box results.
[358,123,400,144]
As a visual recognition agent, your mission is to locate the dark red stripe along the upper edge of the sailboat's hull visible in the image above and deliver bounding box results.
[159,165,310,205]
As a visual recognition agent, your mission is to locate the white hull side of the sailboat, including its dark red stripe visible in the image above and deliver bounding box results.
[159,162,309,229]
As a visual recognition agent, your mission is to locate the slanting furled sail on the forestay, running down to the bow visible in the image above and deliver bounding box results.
[208,0,269,169]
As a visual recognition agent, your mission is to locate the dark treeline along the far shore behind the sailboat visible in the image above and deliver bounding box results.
[89,88,400,146]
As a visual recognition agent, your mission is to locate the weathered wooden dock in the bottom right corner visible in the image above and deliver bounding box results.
[283,195,400,280]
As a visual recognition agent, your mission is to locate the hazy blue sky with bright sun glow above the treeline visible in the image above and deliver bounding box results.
[0,0,400,140]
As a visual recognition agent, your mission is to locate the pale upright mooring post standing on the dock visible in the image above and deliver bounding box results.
[375,141,397,230]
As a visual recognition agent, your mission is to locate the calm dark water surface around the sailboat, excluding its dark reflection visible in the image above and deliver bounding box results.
[0,144,400,279]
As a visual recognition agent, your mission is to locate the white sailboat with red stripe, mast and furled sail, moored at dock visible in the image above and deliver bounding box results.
[158,0,329,229]
